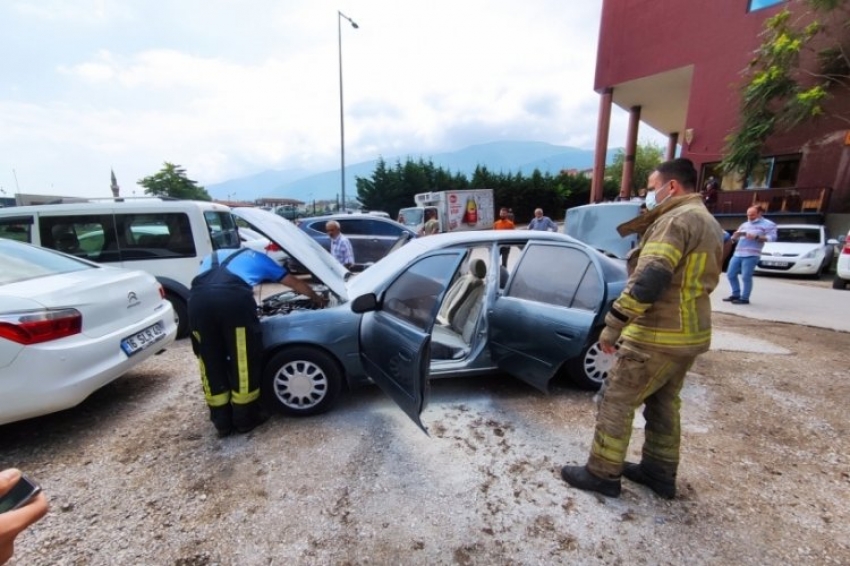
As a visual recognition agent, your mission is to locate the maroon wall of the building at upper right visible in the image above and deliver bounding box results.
[595,0,850,212]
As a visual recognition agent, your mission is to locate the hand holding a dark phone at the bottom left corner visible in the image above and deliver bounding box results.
[0,468,47,564]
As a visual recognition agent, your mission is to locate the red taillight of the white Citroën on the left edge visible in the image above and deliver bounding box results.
[0,309,83,345]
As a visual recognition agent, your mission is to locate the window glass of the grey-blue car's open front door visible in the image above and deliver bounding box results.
[383,254,458,330]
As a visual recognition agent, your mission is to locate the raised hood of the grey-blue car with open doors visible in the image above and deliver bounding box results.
[231,207,351,301]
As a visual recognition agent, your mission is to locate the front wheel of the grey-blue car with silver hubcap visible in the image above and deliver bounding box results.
[262,346,342,417]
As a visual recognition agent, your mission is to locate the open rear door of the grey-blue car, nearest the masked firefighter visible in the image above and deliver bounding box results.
[488,242,605,393]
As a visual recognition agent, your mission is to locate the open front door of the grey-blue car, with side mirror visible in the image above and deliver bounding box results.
[351,250,466,434]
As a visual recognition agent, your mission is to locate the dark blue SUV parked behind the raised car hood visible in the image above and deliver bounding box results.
[298,214,416,264]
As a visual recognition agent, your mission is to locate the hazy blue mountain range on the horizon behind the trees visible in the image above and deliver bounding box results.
[205,141,620,202]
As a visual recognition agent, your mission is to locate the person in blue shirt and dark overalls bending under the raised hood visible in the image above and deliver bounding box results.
[189,248,324,437]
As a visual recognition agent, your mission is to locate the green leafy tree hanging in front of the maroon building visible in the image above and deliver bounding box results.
[722,0,850,173]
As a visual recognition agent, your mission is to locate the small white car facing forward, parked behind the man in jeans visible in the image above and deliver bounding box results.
[756,224,838,277]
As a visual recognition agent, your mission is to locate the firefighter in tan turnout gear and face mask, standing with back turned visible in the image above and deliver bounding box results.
[561,159,723,499]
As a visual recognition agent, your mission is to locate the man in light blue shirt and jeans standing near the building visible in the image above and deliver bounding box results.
[723,206,776,305]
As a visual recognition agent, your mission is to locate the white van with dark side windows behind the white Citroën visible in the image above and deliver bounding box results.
[0,197,240,338]
